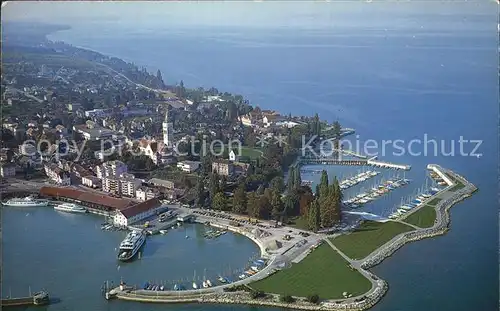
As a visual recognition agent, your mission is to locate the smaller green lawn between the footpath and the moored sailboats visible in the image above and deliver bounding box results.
[332,221,413,259]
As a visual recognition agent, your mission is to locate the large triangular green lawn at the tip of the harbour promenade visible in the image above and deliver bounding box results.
[250,243,371,299]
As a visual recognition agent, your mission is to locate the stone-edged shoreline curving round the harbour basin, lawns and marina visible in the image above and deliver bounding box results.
[112,166,477,311]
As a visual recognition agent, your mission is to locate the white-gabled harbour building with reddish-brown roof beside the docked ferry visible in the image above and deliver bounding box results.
[113,199,166,226]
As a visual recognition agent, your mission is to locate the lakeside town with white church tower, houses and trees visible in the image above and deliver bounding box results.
[0,30,344,233]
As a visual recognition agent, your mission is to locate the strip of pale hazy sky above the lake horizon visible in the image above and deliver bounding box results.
[2,0,496,28]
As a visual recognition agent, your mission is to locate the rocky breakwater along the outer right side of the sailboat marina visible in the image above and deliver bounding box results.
[361,171,477,269]
